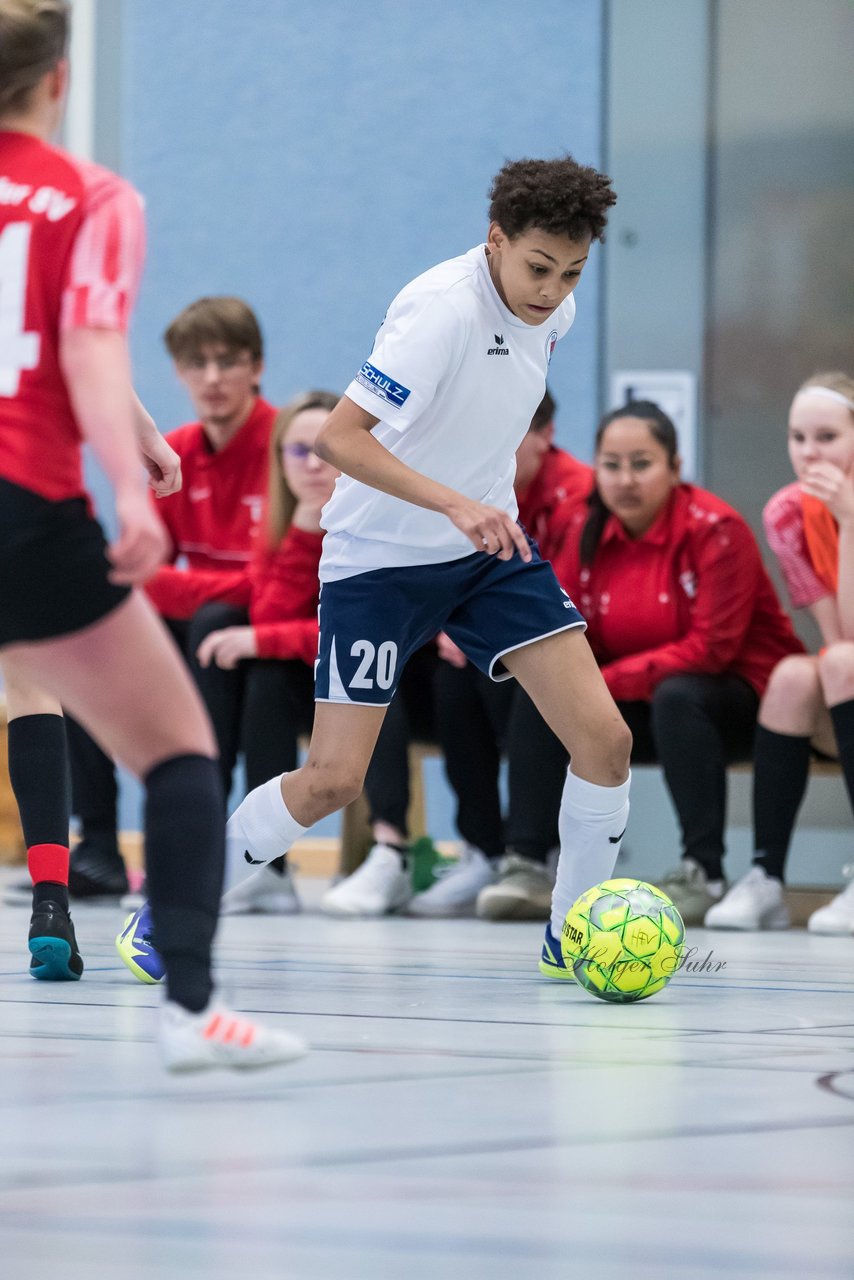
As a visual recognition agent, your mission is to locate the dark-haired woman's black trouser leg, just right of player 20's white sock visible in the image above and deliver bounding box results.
[650,675,759,879]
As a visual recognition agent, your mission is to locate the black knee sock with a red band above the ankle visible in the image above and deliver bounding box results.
[9,714,70,910]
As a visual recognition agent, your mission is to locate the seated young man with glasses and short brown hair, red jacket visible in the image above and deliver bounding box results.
[68,297,275,896]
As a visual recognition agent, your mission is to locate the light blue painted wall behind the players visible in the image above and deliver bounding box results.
[101,0,603,837]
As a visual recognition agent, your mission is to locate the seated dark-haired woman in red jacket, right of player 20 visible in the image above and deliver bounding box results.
[508,401,803,923]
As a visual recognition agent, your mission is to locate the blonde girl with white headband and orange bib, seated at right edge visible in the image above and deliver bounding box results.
[705,372,854,937]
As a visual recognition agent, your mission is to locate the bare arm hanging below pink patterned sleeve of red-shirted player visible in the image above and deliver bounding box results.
[59,329,168,585]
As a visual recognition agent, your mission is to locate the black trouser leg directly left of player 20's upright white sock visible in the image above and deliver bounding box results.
[507,686,568,863]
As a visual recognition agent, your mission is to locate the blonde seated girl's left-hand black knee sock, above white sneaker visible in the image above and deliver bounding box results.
[753,724,809,881]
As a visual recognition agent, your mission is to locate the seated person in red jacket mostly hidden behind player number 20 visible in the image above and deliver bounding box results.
[422,390,593,919]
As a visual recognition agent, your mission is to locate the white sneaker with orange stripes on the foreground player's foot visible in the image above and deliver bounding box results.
[157,1000,309,1071]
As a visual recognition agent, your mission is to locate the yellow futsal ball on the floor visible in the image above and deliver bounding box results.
[561,879,685,1004]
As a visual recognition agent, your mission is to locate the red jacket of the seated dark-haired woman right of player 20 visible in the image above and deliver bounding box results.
[554,484,804,701]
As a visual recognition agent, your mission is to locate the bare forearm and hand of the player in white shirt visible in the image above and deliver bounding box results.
[315,396,531,561]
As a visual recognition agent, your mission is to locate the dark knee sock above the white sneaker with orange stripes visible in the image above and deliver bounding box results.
[145,755,225,1012]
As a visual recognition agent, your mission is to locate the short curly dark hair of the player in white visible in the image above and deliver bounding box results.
[489,155,617,241]
